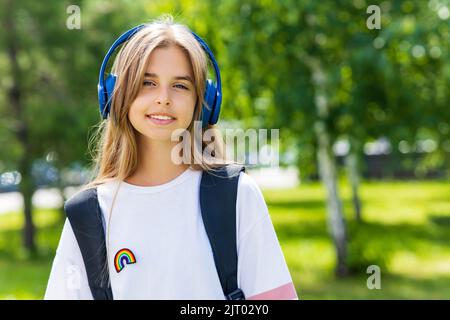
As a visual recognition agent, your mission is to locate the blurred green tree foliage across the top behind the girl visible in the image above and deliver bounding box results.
[0,0,450,175]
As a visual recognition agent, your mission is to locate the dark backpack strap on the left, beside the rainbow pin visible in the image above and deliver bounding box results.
[64,188,113,300]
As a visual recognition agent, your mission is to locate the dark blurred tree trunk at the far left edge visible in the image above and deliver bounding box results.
[4,0,36,253]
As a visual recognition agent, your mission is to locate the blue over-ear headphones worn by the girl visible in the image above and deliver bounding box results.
[97,24,222,127]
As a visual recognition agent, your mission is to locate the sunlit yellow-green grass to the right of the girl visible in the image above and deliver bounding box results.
[264,181,450,299]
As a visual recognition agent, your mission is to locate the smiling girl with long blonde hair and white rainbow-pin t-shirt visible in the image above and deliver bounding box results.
[45,17,297,299]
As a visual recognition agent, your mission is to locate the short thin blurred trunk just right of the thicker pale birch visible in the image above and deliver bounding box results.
[345,138,362,223]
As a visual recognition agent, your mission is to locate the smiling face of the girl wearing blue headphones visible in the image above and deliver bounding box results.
[128,46,197,141]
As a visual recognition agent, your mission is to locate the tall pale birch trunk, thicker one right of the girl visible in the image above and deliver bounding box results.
[305,57,348,277]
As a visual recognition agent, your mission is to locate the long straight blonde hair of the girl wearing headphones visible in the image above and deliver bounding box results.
[81,15,233,190]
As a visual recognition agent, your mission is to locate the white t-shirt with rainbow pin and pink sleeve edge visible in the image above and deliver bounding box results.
[45,169,297,300]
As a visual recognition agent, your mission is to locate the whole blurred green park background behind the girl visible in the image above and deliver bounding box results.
[0,0,450,299]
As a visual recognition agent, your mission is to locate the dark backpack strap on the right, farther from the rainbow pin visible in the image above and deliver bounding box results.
[200,165,245,300]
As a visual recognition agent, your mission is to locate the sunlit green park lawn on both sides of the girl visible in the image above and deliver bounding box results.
[0,181,450,299]
